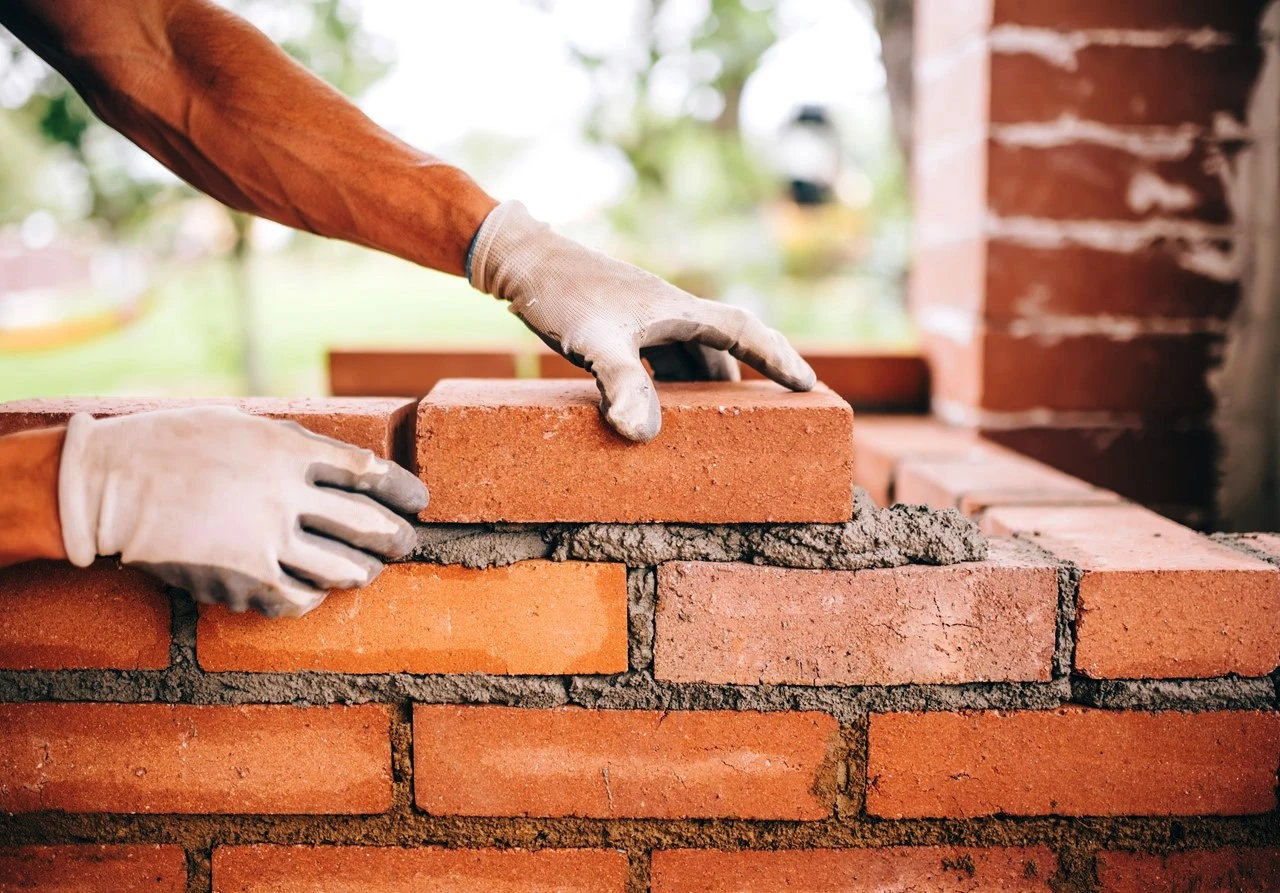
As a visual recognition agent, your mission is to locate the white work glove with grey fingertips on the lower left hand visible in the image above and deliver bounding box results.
[58,407,426,617]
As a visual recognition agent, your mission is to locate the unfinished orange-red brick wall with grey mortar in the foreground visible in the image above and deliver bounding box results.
[0,381,1280,893]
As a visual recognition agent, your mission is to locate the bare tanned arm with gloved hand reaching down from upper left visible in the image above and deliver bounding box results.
[0,0,814,440]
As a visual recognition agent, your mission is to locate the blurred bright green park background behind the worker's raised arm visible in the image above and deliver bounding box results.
[0,0,913,399]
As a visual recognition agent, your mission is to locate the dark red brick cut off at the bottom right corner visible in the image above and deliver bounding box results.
[1098,848,1280,893]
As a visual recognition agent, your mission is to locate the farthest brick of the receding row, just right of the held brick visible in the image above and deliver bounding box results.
[854,416,980,505]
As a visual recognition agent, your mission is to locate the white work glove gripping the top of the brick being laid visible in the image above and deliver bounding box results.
[467,202,817,441]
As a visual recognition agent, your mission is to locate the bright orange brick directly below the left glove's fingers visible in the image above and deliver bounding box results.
[196,560,627,674]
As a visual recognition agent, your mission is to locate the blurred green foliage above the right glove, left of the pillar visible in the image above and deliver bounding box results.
[563,0,909,303]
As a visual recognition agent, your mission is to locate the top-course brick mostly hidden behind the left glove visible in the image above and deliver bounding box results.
[0,397,413,464]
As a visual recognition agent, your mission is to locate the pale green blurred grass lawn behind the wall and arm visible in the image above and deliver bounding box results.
[0,239,911,400]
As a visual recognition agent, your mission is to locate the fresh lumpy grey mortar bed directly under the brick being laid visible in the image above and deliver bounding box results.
[407,489,987,571]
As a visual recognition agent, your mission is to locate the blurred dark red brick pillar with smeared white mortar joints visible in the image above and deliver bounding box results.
[910,0,1266,523]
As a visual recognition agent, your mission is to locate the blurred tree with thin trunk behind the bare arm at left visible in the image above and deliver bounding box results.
[0,0,392,393]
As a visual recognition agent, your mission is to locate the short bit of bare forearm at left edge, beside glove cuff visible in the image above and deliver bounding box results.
[0,427,67,567]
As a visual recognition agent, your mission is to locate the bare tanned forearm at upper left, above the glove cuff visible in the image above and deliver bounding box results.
[0,0,497,274]
